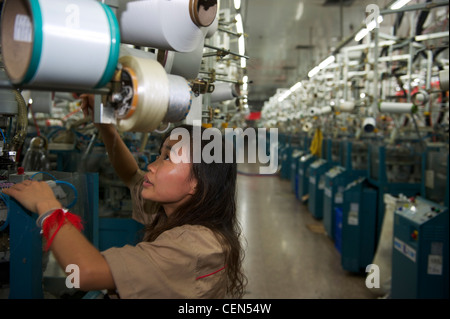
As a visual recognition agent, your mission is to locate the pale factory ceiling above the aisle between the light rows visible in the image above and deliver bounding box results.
[221,0,392,111]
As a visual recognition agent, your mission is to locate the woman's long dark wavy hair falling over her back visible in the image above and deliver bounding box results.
[135,124,247,298]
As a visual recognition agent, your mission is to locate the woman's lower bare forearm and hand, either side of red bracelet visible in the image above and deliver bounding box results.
[3,180,115,291]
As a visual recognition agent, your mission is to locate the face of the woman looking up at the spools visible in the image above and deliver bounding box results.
[141,138,197,216]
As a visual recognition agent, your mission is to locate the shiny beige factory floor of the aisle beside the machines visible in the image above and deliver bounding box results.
[237,164,377,299]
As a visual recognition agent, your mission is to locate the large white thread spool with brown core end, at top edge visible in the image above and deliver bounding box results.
[117,0,217,52]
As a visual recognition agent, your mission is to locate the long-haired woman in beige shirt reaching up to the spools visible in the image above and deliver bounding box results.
[3,96,246,299]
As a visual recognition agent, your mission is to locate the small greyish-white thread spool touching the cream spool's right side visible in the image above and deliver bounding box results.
[163,74,193,123]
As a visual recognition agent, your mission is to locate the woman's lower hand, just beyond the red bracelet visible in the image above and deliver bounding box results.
[3,180,62,215]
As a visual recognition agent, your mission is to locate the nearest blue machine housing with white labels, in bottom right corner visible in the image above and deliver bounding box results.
[391,197,449,299]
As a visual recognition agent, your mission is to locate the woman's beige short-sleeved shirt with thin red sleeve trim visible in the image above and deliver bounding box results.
[102,171,227,299]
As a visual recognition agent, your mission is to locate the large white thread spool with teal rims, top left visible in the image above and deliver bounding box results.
[1,0,120,89]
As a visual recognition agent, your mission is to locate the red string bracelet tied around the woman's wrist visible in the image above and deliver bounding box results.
[42,208,83,251]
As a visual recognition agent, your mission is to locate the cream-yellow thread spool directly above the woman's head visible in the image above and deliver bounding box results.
[117,56,169,132]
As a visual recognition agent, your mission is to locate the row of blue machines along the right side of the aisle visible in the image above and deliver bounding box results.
[279,136,449,298]
